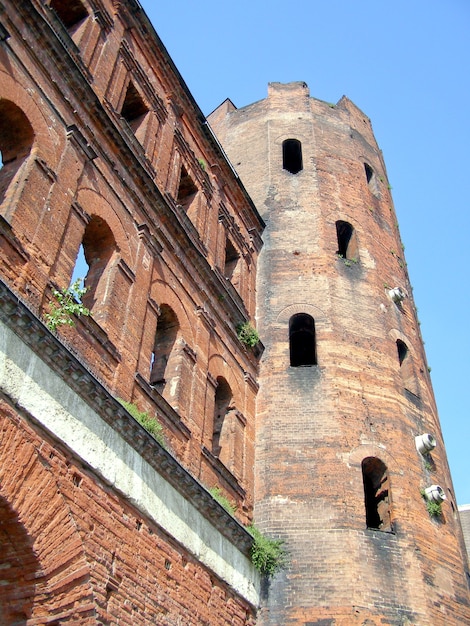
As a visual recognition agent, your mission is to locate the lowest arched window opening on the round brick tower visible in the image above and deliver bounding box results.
[362,457,392,531]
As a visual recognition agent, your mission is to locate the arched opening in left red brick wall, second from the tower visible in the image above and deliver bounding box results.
[150,304,179,392]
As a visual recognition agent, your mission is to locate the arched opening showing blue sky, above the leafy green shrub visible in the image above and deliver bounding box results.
[80,215,118,319]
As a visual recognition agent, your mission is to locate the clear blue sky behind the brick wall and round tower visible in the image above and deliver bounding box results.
[141,0,470,504]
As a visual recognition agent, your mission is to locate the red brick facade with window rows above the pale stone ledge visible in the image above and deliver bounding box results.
[0,0,263,522]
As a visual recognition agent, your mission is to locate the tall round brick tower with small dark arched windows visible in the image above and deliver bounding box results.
[209,83,470,626]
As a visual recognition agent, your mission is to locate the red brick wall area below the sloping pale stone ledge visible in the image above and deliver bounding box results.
[0,402,253,625]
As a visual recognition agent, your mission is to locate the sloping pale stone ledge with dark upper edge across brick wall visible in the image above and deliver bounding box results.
[0,281,259,605]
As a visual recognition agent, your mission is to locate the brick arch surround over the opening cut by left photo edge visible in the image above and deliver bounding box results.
[0,69,61,170]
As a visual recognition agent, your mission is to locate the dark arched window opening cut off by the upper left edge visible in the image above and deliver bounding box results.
[0,99,34,203]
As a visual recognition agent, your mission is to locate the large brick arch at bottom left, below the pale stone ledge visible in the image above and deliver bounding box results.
[0,404,94,624]
